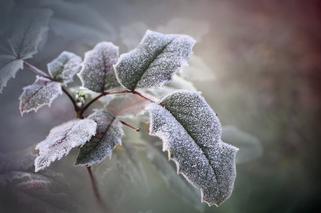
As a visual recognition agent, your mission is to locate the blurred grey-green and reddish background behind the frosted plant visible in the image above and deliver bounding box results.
[0,0,321,213]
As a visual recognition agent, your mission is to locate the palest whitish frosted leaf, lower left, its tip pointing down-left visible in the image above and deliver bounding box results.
[35,119,97,172]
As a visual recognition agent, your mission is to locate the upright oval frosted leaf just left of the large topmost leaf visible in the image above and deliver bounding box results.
[79,42,119,92]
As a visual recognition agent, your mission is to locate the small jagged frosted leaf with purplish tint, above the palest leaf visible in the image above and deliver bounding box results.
[19,76,62,115]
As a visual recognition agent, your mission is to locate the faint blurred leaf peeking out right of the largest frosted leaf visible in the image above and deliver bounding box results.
[222,126,263,164]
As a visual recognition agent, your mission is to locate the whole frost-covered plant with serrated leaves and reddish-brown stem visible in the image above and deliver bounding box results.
[0,7,238,211]
